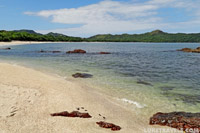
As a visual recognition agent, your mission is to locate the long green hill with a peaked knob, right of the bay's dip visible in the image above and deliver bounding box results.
[88,30,200,42]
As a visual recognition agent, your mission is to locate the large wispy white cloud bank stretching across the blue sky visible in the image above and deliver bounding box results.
[24,0,199,36]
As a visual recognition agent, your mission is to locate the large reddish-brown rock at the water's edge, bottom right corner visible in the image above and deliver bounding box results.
[149,112,200,132]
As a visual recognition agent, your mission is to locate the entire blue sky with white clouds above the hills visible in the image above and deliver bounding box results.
[0,0,200,37]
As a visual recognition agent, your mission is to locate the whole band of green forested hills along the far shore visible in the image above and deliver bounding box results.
[0,30,200,42]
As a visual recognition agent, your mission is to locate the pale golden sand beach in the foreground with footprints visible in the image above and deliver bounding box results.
[0,63,178,133]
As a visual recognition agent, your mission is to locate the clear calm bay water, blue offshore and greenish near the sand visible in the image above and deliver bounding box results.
[0,43,200,114]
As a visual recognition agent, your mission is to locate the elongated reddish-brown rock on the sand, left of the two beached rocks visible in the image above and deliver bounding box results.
[51,111,92,118]
